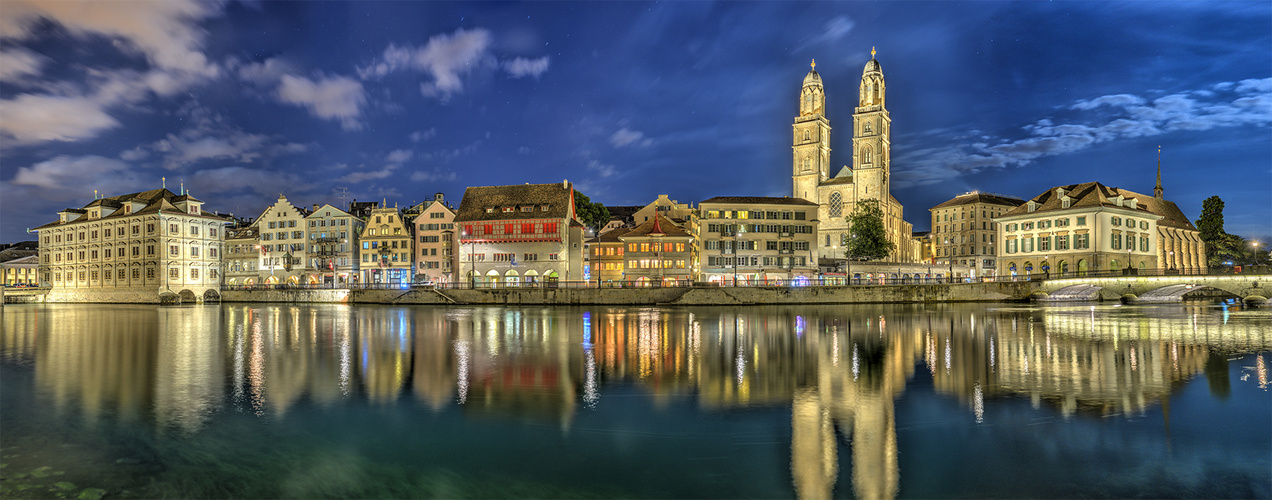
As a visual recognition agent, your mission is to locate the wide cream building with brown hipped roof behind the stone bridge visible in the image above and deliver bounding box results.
[995,181,1206,276]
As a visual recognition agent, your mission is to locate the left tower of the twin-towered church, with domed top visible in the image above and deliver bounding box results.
[791,61,831,198]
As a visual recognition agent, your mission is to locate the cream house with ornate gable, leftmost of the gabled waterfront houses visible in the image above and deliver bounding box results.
[253,195,310,285]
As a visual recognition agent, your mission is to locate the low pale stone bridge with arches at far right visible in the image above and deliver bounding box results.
[1033,275,1272,305]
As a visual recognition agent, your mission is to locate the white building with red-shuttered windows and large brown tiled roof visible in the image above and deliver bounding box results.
[455,181,585,286]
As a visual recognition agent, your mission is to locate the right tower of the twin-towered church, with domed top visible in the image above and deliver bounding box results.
[852,48,892,202]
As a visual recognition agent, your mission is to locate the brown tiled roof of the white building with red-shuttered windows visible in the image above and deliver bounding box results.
[455,183,574,223]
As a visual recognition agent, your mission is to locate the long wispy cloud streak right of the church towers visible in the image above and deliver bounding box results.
[895,78,1272,187]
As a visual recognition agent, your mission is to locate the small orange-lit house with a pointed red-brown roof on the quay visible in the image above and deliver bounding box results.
[618,212,698,286]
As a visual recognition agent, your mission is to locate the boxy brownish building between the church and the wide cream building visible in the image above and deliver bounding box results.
[927,191,1025,277]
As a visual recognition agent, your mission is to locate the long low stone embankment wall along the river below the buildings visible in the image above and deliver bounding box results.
[221,281,1037,305]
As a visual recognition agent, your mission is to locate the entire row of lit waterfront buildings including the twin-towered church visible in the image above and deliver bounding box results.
[24,51,1205,296]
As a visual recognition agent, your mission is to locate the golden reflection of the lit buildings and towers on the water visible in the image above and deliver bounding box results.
[0,304,1272,497]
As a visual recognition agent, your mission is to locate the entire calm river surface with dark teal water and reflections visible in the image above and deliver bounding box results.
[0,297,1272,499]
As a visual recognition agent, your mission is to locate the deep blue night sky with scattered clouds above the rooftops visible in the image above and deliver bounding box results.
[0,0,1272,242]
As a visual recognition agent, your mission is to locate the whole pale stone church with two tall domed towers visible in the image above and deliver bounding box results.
[791,48,917,262]
